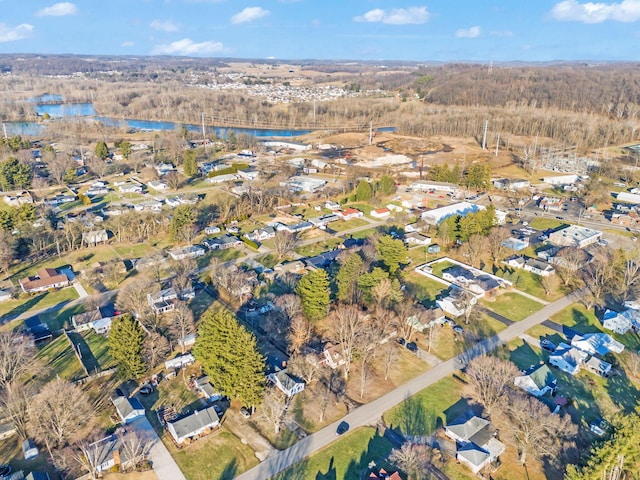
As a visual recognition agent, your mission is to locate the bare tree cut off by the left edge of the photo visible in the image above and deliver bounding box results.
[0,331,37,388]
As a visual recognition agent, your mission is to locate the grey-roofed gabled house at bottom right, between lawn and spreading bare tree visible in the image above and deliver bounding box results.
[444,412,505,474]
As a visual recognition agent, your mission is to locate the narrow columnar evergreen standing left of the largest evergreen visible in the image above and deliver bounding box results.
[109,315,146,379]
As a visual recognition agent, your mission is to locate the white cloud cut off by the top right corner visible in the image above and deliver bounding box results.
[551,0,640,23]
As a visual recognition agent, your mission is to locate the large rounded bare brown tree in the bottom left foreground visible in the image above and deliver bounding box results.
[29,378,93,452]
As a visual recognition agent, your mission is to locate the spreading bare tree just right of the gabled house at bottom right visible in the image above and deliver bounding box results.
[505,394,578,465]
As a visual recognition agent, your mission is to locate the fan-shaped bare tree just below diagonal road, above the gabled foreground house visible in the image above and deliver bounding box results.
[466,355,520,412]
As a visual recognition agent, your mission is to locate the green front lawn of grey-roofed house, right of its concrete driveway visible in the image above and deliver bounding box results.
[169,428,258,480]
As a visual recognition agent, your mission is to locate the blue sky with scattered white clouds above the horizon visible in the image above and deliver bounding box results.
[0,0,640,62]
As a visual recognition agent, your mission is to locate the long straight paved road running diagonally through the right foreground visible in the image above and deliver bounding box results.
[237,292,580,480]
